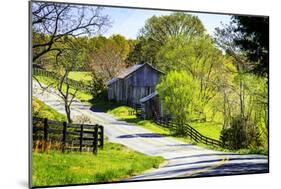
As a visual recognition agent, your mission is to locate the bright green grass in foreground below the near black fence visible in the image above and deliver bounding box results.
[32,143,164,186]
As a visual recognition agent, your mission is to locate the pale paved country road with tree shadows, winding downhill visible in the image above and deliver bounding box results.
[33,82,268,180]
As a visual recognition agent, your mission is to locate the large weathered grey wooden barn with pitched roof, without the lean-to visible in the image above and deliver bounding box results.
[107,63,163,105]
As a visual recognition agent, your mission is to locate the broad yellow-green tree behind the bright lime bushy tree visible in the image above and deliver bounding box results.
[156,35,224,119]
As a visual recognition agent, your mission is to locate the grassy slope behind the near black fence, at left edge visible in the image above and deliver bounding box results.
[32,97,67,121]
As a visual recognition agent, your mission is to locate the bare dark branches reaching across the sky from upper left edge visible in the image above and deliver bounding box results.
[32,2,110,63]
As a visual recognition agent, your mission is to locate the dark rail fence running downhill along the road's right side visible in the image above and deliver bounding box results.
[154,117,223,147]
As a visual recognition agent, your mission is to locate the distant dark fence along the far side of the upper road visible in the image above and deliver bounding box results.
[33,68,91,93]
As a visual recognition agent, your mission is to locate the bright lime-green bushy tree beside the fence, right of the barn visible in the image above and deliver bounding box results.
[156,71,200,134]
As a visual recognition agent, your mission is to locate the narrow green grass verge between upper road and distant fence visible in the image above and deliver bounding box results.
[34,76,93,102]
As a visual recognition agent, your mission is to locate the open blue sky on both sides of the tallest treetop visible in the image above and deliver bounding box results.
[100,7,230,39]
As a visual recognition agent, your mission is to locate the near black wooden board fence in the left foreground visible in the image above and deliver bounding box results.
[33,117,104,154]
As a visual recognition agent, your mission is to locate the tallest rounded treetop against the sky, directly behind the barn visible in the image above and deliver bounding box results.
[128,13,205,65]
